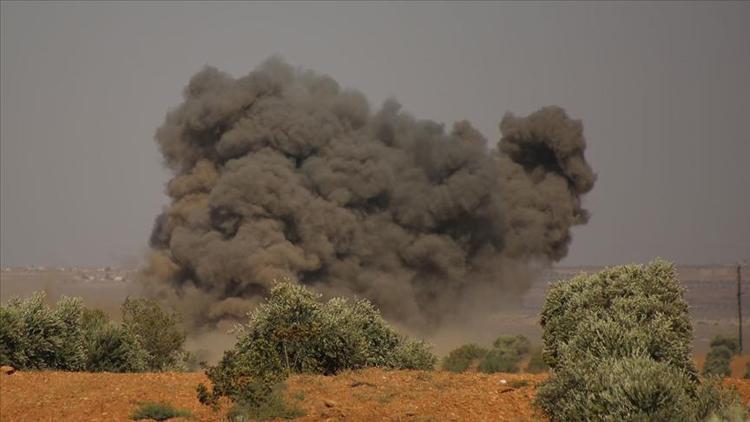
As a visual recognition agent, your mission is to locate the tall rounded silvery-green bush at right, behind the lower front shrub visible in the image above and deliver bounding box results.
[540,260,695,372]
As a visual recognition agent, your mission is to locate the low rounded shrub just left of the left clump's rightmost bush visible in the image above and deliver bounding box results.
[86,323,148,372]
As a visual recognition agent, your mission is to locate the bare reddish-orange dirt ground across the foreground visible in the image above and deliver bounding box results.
[0,362,750,422]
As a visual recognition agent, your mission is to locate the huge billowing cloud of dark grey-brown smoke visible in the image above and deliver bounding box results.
[143,58,595,330]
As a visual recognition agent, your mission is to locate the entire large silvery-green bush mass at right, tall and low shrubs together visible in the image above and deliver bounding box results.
[536,260,736,421]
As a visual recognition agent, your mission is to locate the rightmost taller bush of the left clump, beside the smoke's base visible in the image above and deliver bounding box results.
[122,298,185,371]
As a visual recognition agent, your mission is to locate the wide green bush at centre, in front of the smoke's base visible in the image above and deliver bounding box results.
[198,281,436,418]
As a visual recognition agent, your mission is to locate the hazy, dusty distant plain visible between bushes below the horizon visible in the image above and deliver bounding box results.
[0,266,750,362]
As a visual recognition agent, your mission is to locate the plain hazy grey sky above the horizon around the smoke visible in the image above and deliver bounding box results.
[0,2,750,266]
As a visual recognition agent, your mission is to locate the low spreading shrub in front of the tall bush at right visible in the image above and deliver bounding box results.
[535,351,736,421]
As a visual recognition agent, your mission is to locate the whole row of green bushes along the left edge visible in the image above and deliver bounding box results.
[0,292,184,372]
